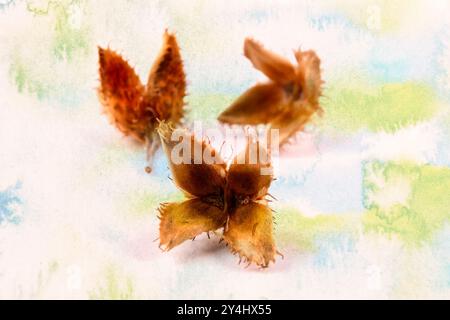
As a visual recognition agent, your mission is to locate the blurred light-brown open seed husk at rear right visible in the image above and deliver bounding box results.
[218,39,322,144]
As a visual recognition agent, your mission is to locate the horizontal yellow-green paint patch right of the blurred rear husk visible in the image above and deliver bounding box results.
[321,79,439,132]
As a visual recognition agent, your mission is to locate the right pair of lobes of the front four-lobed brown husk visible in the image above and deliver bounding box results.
[223,140,276,268]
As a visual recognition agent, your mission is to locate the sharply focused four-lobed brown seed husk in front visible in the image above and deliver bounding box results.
[158,123,276,267]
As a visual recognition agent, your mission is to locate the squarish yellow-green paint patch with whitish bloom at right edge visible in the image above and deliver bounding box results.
[363,161,450,245]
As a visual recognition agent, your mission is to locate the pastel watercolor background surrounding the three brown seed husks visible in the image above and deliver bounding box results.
[0,0,450,299]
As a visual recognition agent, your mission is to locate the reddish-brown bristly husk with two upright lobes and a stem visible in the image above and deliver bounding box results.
[98,31,186,171]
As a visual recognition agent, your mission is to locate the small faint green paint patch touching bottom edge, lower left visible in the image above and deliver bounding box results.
[89,265,136,300]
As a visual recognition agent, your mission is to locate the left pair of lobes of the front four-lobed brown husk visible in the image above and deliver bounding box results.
[158,122,227,250]
